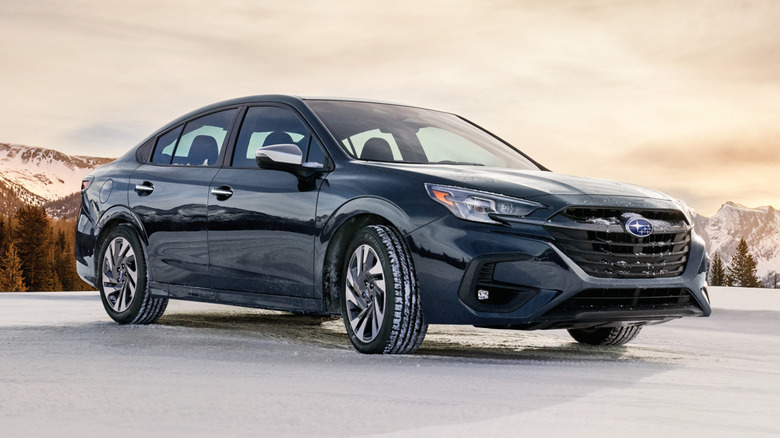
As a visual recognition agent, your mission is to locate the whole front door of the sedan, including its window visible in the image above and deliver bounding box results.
[208,106,325,297]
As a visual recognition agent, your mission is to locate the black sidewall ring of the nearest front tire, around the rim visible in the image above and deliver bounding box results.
[339,227,398,354]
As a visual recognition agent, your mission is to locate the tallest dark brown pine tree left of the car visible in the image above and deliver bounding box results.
[14,205,59,292]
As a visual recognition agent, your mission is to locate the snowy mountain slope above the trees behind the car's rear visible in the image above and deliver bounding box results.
[0,143,113,217]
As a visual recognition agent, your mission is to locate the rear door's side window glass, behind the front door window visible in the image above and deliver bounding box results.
[172,109,238,166]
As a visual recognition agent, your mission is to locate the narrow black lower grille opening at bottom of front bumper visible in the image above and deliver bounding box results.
[556,288,695,312]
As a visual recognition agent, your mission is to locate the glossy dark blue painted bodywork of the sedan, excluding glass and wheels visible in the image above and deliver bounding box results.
[76,96,711,328]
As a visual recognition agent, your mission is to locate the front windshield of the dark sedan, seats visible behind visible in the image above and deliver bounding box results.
[306,100,539,170]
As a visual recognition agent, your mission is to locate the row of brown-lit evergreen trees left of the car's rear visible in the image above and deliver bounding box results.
[0,205,93,292]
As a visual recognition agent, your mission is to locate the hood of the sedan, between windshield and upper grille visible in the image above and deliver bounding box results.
[368,163,672,200]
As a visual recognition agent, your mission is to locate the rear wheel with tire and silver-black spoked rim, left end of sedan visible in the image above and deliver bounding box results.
[98,225,168,324]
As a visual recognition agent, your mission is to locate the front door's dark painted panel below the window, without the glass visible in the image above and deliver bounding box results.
[208,168,321,298]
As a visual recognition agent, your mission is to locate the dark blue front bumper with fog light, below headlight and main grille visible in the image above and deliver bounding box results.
[408,216,711,329]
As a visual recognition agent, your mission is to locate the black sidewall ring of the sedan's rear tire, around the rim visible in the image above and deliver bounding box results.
[97,225,148,324]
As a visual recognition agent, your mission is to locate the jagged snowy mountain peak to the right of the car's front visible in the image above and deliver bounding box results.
[693,202,780,278]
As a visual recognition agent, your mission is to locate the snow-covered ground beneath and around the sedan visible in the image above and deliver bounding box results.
[0,288,780,438]
